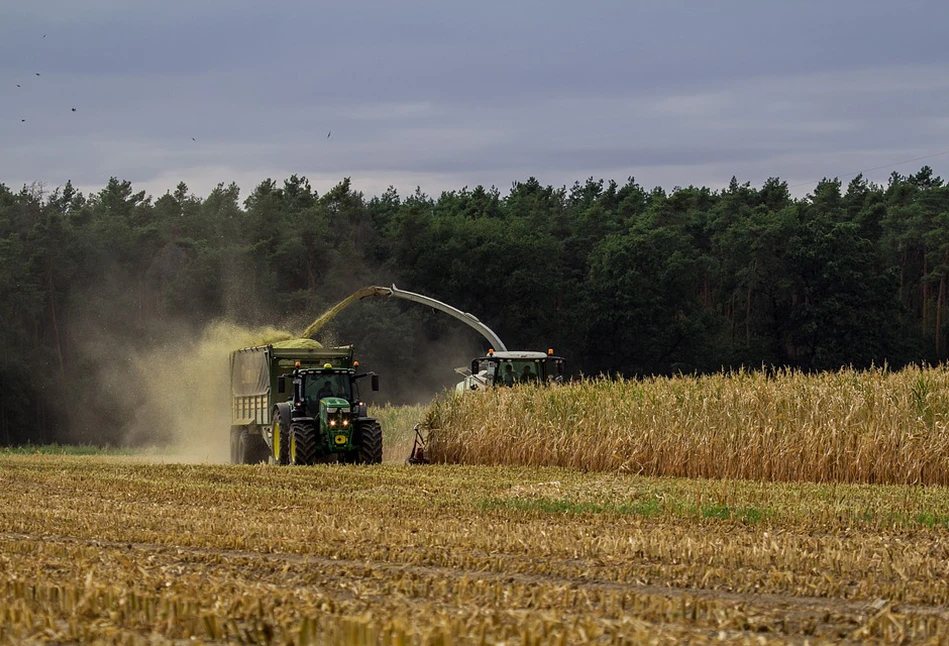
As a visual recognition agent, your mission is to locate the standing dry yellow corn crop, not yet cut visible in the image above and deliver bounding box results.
[426,367,949,486]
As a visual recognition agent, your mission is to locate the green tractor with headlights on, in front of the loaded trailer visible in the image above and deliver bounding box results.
[272,362,382,464]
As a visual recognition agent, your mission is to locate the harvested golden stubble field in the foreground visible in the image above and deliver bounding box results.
[0,454,949,644]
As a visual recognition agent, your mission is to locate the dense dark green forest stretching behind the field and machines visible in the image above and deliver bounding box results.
[0,167,949,444]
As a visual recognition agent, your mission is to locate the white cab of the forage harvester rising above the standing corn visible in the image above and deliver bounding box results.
[456,350,564,391]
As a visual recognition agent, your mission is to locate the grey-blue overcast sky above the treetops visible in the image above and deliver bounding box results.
[0,0,949,196]
